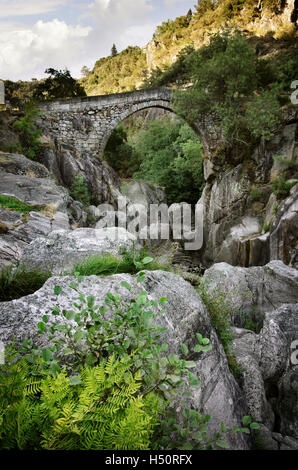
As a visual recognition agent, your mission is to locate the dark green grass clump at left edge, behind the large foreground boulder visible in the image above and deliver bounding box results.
[0,266,51,302]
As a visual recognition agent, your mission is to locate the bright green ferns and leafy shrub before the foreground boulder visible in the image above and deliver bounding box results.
[0,274,258,450]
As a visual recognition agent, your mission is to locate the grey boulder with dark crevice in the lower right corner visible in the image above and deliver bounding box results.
[232,304,298,449]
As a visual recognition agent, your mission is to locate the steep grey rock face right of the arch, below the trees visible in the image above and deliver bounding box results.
[194,114,298,267]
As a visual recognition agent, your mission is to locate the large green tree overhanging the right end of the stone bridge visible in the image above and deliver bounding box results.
[173,30,279,152]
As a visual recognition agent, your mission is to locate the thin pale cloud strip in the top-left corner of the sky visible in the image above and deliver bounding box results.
[0,0,68,18]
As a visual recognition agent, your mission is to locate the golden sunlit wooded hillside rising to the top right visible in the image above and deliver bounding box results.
[80,0,297,95]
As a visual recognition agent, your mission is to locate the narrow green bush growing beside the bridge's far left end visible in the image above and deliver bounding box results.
[14,101,42,160]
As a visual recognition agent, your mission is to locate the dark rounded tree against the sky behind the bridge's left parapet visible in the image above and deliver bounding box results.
[33,68,86,101]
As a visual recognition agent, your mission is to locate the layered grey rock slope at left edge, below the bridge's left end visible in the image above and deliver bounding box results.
[0,168,69,266]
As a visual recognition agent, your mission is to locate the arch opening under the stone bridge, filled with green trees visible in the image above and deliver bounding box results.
[103,103,205,204]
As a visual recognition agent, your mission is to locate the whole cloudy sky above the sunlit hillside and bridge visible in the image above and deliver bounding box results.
[0,0,197,81]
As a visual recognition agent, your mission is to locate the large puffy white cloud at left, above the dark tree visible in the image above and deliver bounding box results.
[0,19,92,80]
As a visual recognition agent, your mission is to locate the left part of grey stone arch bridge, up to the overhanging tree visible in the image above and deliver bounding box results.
[38,88,172,159]
